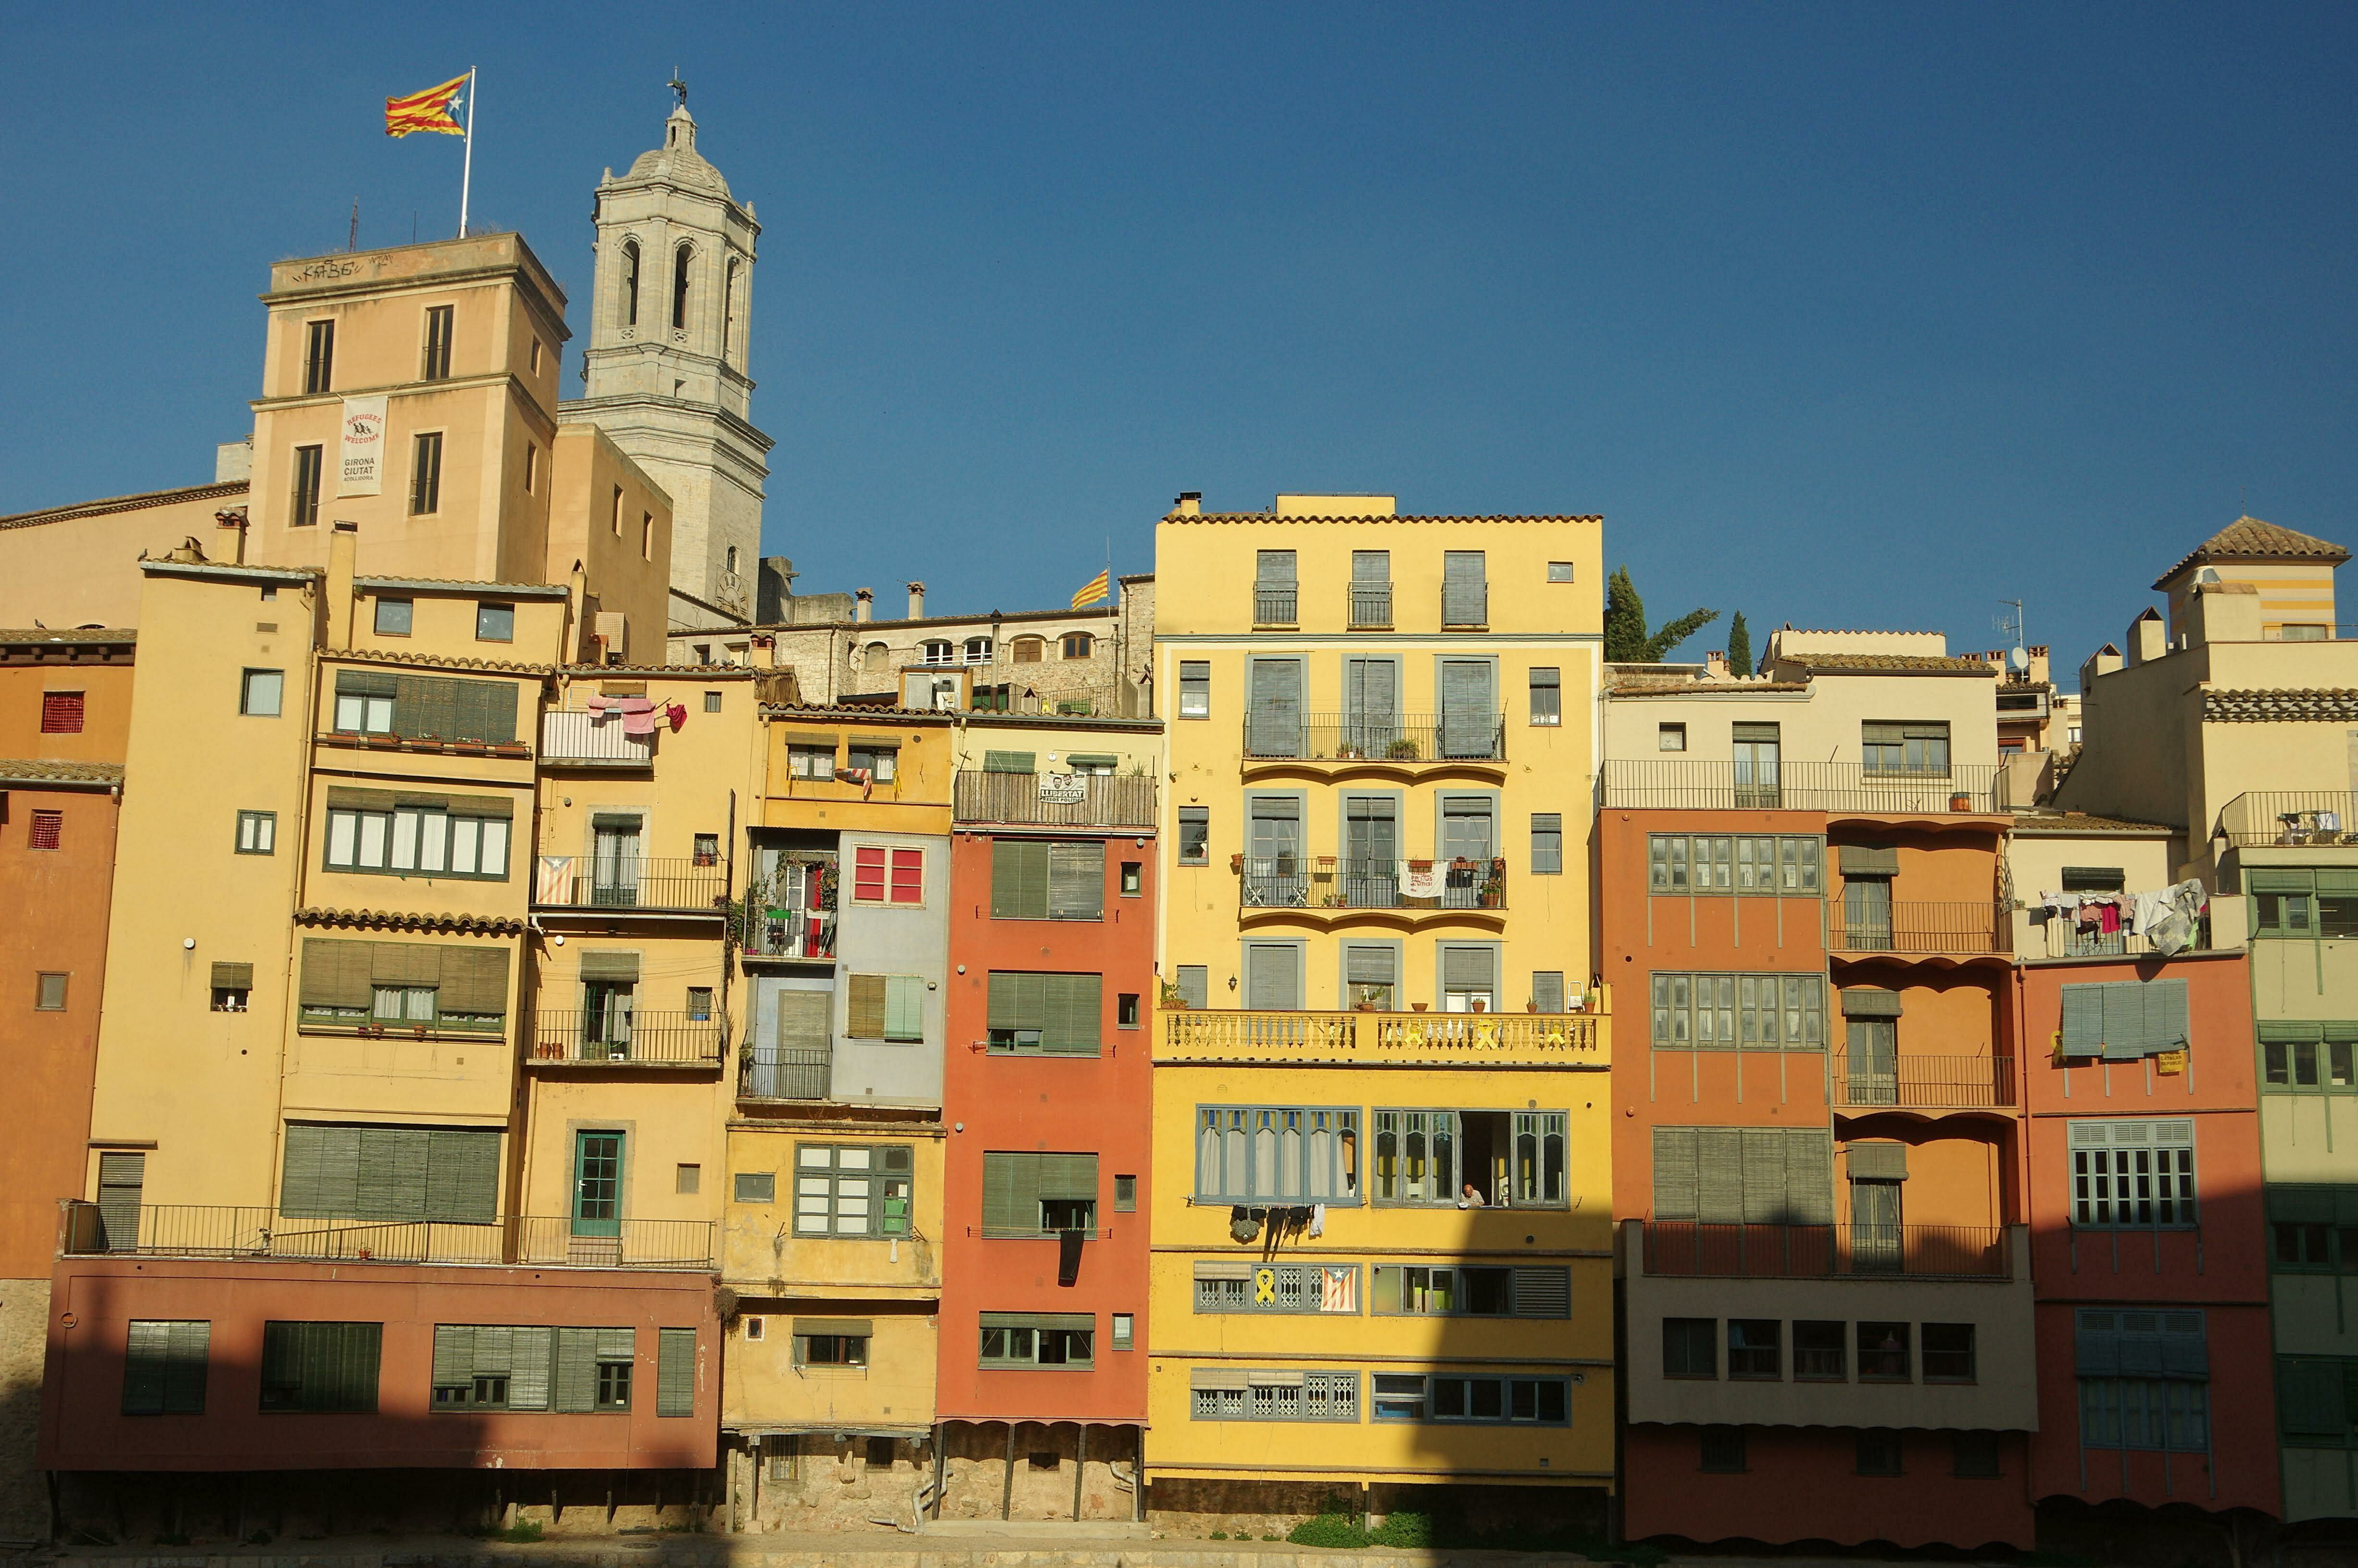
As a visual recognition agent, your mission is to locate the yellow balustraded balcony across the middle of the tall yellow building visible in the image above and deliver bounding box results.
[1155,1009,1608,1068]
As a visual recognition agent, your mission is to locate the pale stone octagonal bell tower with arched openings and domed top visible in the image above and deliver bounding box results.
[559,83,771,627]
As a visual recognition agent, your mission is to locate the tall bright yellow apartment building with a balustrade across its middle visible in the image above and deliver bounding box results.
[1148,495,1615,1511]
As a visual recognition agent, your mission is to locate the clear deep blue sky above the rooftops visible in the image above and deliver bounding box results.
[0,0,2358,679]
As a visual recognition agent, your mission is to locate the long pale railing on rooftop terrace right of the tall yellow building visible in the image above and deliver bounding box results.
[1603,757,2007,816]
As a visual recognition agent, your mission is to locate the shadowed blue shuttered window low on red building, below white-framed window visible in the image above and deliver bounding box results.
[2072,1307,2207,1453]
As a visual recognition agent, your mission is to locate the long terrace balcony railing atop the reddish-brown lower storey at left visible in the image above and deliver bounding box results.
[59,1198,714,1269]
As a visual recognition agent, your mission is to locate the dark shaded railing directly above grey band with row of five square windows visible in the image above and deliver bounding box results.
[1646,1219,2014,1281]
